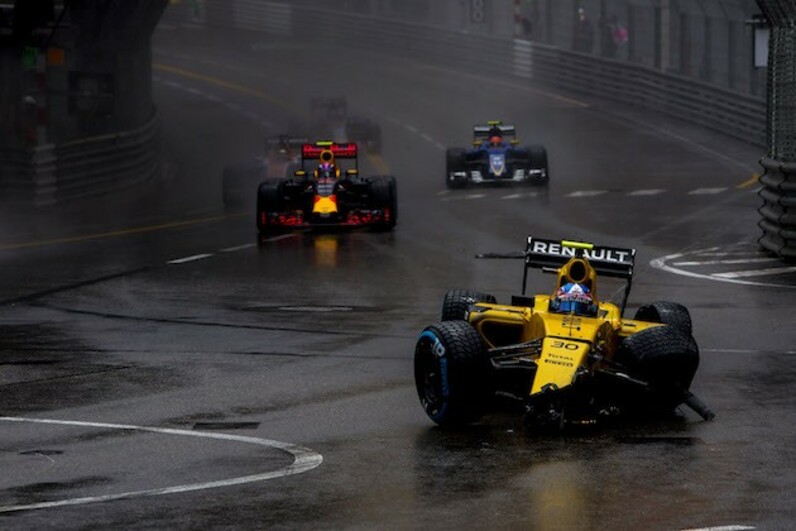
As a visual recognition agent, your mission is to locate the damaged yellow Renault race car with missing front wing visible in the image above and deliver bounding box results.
[414,237,714,429]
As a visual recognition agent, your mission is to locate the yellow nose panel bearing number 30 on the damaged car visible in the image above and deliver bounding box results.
[531,337,591,394]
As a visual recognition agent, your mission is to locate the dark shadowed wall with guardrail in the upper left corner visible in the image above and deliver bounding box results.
[0,0,167,205]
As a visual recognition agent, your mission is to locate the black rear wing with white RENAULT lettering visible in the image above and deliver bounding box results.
[525,236,636,279]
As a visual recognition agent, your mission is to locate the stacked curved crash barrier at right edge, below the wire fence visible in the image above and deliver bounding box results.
[759,158,796,260]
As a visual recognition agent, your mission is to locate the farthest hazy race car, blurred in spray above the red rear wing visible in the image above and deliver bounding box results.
[310,97,381,153]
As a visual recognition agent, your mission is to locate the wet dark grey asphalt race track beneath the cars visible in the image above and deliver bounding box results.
[0,26,796,529]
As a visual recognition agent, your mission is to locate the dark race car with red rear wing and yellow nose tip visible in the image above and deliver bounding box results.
[257,141,398,233]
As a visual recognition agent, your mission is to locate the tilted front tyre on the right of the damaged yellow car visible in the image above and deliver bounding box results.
[616,326,699,410]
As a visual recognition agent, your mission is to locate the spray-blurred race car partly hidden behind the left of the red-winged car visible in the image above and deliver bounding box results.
[221,135,309,207]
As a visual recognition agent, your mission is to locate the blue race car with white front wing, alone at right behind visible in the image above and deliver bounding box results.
[445,121,550,188]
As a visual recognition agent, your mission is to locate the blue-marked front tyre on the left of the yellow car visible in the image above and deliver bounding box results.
[414,321,491,426]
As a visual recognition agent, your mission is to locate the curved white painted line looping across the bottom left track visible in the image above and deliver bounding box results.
[0,417,323,513]
